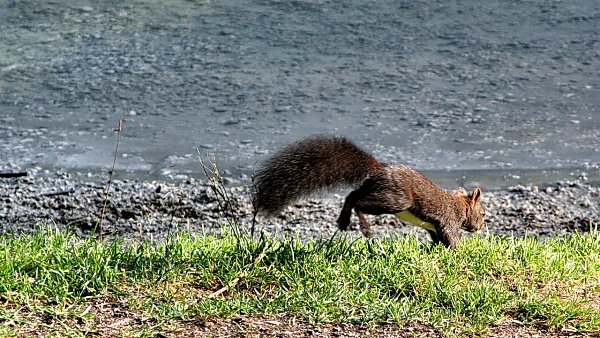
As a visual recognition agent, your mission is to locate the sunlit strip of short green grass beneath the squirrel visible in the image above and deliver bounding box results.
[0,230,600,336]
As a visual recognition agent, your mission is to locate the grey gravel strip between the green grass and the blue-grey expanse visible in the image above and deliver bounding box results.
[0,173,600,241]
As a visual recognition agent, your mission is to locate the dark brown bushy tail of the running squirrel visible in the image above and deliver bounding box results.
[252,136,380,215]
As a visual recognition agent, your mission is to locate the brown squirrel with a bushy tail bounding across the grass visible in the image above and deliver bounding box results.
[252,135,484,248]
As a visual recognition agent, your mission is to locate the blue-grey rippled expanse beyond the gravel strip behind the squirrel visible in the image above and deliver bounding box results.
[0,0,600,187]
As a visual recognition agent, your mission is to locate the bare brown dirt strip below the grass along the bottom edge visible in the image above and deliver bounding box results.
[4,299,592,338]
